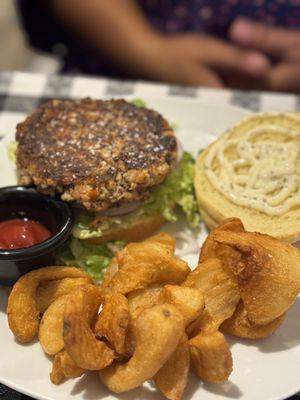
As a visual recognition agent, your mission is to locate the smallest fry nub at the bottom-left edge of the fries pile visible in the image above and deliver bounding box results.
[50,350,85,385]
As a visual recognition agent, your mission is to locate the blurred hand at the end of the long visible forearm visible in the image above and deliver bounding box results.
[134,34,270,87]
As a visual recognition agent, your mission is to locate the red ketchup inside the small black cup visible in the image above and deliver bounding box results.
[0,218,51,250]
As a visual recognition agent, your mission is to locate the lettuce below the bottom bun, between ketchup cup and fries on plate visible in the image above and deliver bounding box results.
[56,237,125,282]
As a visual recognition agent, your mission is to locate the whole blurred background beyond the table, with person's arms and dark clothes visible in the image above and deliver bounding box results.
[0,0,300,93]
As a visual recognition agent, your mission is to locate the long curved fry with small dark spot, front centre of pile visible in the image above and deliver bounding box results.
[99,304,184,393]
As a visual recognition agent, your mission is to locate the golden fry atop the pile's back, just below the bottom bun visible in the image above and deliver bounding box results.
[102,240,190,295]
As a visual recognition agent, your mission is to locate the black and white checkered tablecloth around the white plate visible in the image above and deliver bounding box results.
[0,71,300,400]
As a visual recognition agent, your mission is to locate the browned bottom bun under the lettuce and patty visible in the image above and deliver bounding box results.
[87,215,166,244]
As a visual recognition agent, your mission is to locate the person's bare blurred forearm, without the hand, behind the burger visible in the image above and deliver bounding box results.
[51,0,159,74]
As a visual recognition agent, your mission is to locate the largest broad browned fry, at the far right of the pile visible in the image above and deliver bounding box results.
[213,231,300,325]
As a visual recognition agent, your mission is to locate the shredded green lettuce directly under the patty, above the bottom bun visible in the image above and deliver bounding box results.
[73,153,201,239]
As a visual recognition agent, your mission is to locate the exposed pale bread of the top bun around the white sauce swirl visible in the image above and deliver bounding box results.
[195,113,300,242]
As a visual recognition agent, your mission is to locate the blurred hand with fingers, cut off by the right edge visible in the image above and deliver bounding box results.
[229,18,300,92]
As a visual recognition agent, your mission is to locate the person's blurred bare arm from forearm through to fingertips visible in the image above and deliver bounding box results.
[51,0,268,87]
